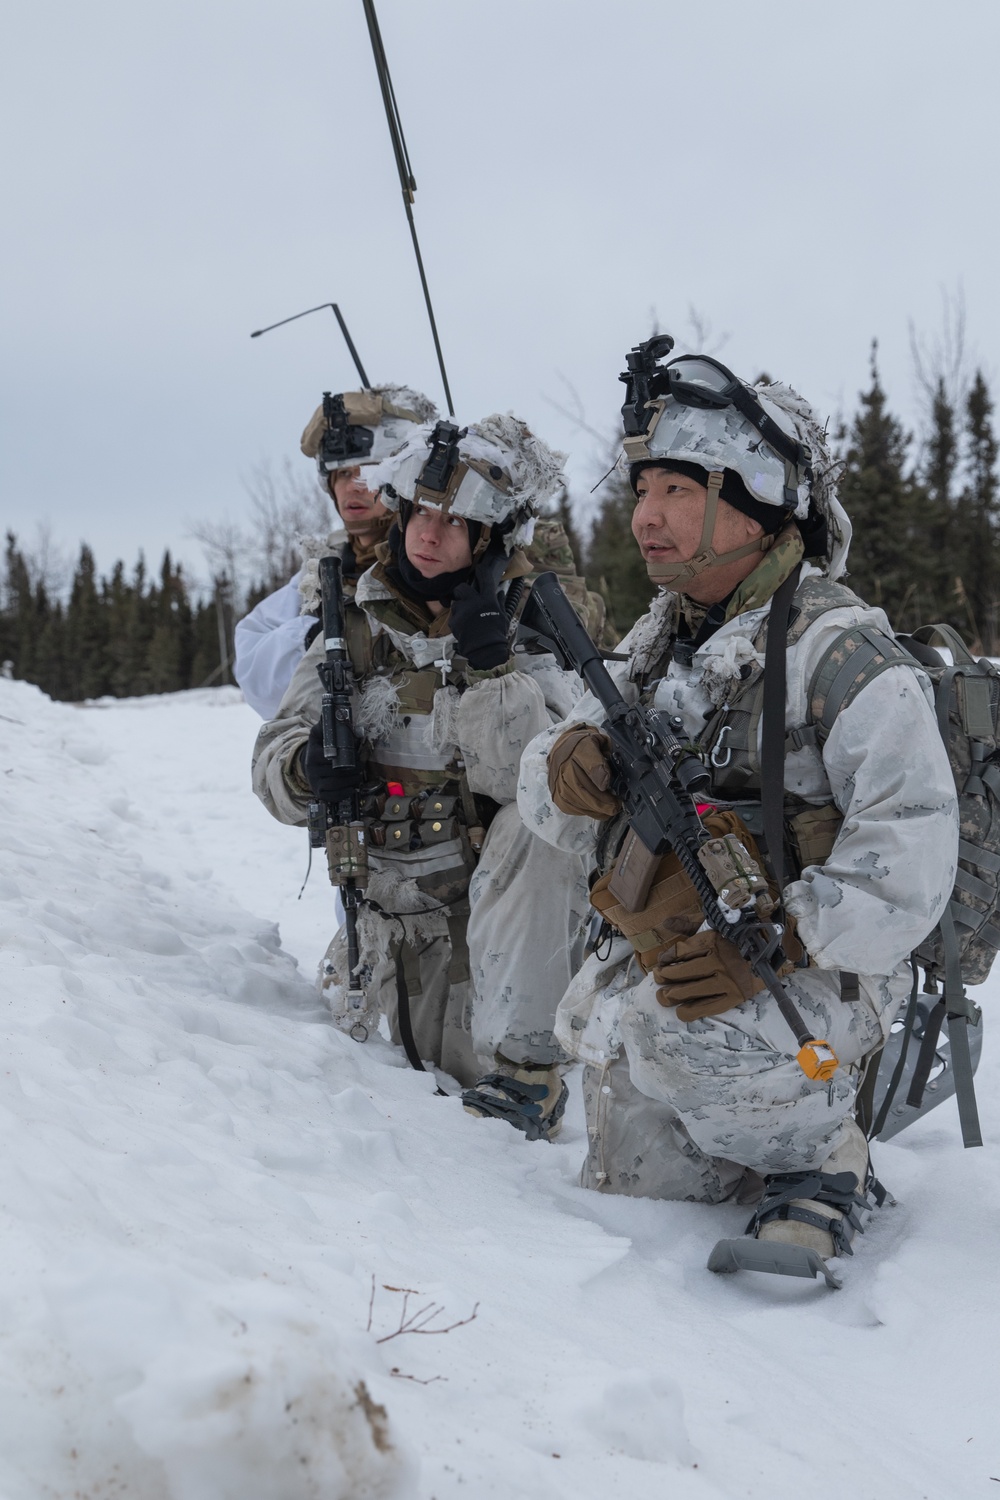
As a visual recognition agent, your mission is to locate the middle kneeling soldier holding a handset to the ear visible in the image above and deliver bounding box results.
[253,416,588,1139]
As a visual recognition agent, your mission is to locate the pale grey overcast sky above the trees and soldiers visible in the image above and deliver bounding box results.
[0,0,1000,582]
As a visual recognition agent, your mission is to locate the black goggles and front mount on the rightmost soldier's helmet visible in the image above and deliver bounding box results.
[618,333,810,470]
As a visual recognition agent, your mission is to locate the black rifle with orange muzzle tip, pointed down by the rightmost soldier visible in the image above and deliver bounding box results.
[522,573,840,1082]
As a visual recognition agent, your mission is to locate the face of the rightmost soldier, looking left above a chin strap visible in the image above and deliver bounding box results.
[631,468,763,585]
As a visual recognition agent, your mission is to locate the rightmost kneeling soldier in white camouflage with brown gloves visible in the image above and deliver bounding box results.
[519,338,958,1274]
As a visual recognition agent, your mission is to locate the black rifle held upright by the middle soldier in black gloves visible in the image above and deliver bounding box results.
[309,557,369,1041]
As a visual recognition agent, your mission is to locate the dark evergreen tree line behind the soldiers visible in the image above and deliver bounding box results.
[7,345,1000,702]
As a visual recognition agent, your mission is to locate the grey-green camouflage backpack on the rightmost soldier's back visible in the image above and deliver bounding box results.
[810,624,1000,1146]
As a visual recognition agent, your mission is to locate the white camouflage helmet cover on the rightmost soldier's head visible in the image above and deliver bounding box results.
[622,381,852,578]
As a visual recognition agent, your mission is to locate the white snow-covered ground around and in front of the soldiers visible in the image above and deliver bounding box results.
[0,681,1000,1500]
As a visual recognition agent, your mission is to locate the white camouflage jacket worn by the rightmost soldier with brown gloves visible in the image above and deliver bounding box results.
[517,564,958,993]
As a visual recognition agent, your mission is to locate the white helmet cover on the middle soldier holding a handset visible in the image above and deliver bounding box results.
[364,413,565,540]
